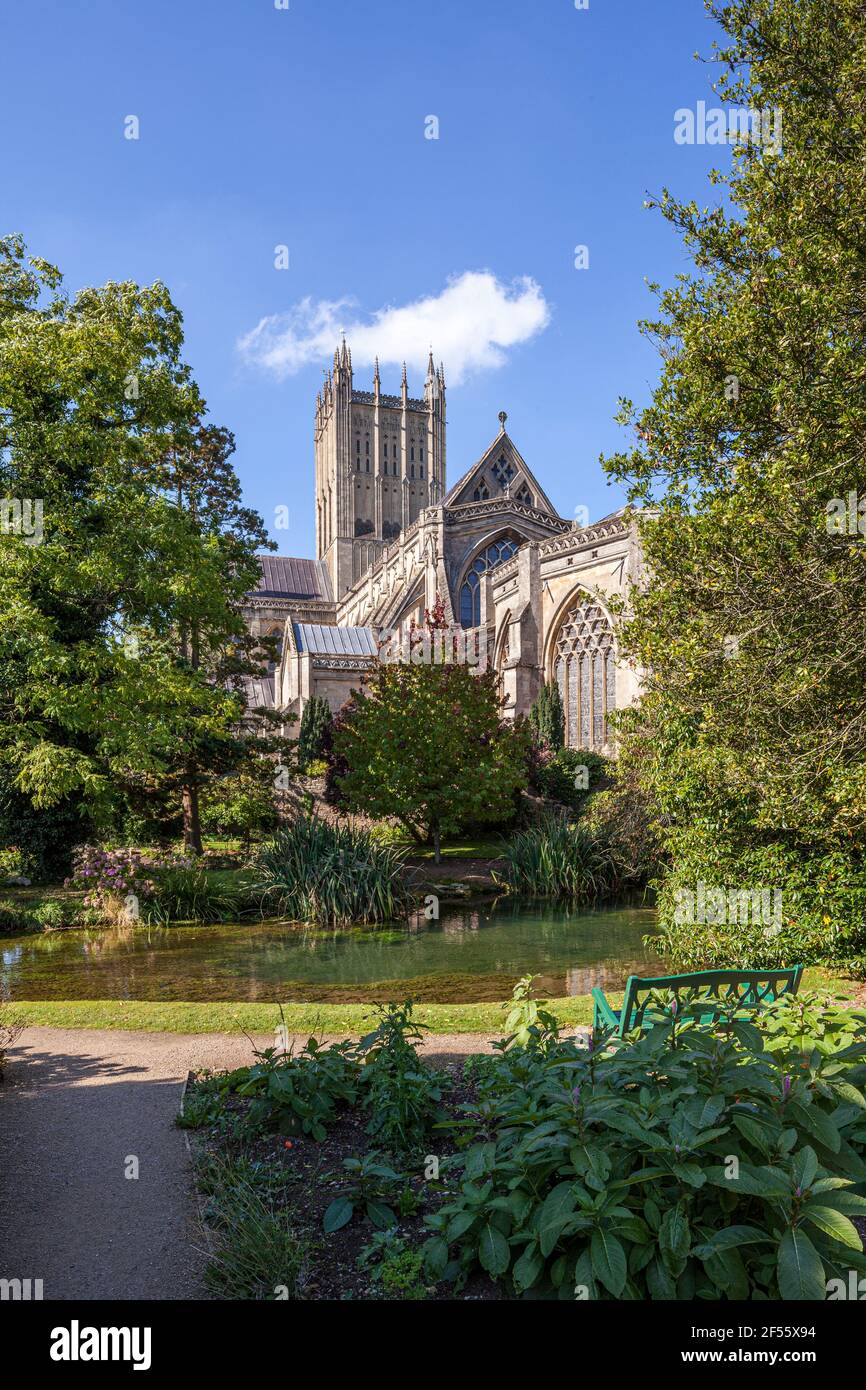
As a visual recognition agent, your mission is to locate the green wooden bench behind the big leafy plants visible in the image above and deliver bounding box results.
[592,965,803,1037]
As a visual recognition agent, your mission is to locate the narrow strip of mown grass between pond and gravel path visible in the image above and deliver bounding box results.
[8,969,863,1037]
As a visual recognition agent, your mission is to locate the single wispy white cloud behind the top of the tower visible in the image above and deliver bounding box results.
[238,270,550,384]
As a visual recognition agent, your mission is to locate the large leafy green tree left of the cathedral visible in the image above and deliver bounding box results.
[0,236,279,849]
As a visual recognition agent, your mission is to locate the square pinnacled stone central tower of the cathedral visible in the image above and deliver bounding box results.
[314,339,445,602]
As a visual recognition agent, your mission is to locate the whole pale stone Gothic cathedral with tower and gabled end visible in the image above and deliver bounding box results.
[240,342,641,752]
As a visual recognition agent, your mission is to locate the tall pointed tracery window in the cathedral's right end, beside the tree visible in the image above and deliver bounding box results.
[553,598,616,752]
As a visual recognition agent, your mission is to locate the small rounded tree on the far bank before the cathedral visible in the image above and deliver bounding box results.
[334,663,527,863]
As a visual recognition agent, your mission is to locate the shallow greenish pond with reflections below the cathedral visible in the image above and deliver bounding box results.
[0,899,659,1004]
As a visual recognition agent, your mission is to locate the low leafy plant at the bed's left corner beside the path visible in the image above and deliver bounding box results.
[223,1038,360,1140]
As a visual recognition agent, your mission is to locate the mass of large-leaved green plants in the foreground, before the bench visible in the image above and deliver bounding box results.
[424,997,866,1300]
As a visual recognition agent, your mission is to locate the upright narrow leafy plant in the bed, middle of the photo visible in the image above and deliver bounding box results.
[360,999,445,1152]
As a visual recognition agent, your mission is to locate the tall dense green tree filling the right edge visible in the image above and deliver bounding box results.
[607,0,866,954]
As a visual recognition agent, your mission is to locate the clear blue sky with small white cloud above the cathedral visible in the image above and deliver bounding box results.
[0,0,727,555]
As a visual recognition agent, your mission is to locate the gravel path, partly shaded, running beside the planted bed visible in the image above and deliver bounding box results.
[0,1027,508,1300]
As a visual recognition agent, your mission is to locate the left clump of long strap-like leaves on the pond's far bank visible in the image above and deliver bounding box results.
[253,816,407,927]
